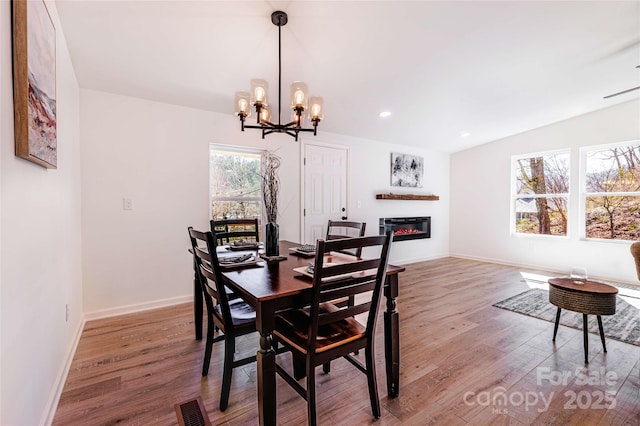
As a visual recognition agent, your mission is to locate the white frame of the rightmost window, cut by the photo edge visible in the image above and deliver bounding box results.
[577,139,640,244]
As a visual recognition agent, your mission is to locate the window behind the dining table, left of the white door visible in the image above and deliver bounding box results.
[209,145,262,220]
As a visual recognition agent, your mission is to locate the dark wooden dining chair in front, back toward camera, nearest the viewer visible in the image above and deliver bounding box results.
[273,231,391,425]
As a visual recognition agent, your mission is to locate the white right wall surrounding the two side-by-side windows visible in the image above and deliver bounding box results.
[451,101,640,283]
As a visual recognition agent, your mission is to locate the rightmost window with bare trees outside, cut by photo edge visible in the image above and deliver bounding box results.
[582,141,640,240]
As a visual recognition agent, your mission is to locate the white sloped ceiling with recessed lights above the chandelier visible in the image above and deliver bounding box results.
[56,0,640,152]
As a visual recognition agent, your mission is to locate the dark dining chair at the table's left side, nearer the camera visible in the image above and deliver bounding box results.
[188,226,256,411]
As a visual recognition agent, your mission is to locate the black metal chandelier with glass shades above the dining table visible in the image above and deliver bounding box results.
[235,11,324,141]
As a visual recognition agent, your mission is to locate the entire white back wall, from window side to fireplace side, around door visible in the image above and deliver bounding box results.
[80,90,449,318]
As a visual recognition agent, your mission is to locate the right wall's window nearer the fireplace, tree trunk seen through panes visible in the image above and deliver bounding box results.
[512,151,569,236]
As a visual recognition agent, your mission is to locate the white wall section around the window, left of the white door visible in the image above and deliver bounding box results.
[80,90,299,317]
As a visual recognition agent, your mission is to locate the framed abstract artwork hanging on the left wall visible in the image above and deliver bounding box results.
[11,0,58,169]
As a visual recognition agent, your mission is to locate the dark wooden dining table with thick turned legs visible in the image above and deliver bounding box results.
[188,241,405,425]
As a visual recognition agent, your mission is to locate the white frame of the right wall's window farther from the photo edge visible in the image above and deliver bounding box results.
[509,148,573,240]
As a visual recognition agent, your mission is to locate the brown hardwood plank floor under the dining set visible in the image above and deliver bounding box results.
[53,258,640,426]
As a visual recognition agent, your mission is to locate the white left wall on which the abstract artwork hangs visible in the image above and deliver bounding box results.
[0,1,83,425]
